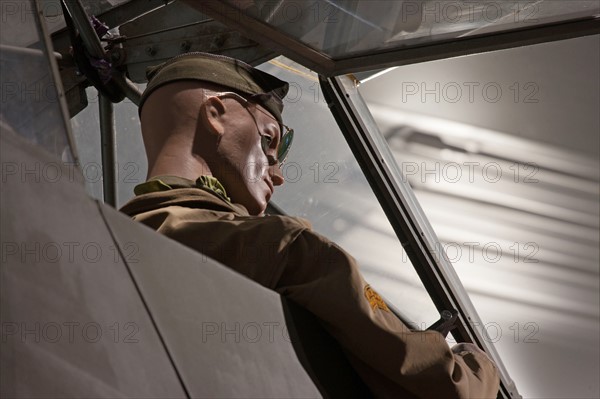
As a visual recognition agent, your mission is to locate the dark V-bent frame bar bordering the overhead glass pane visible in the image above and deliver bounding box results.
[195,0,600,77]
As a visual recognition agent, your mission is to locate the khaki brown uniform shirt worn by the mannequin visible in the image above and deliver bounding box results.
[122,177,499,398]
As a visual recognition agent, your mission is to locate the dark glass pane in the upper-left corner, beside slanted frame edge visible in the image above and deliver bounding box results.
[0,1,72,162]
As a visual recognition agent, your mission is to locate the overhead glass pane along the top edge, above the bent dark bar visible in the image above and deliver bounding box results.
[221,0,600,59]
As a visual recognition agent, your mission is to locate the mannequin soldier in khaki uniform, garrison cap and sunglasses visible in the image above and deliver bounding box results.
[122,53,499,398]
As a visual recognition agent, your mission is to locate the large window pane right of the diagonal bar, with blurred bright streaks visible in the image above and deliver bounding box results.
[359,35,600,397]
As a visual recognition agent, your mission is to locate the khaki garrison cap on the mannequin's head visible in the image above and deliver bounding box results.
[139,52,288,124]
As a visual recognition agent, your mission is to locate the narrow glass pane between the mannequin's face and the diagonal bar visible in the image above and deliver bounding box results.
[260,57,439,328]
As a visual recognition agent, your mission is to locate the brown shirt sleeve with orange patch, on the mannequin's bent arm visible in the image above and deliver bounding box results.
[275,230,499,398]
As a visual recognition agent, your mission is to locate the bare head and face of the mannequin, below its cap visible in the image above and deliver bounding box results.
[140,80,284,215]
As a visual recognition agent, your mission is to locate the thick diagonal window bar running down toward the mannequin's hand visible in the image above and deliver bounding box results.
[320,76,521,399]
